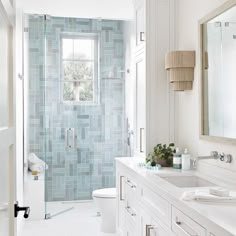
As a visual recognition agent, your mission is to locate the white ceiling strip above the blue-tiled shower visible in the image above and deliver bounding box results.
[23,0,133,19]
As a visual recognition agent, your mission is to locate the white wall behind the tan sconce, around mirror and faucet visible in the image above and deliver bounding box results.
[175,0,236,186]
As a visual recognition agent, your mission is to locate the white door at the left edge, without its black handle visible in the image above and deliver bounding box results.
[0,1,16,236]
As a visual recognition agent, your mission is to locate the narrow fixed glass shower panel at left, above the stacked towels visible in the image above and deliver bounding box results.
[24,15,47,217]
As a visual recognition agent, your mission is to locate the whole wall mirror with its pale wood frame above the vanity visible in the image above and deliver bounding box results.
[199,0,236,144]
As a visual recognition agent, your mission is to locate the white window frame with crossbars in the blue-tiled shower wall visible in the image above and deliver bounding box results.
[60,32,100,105]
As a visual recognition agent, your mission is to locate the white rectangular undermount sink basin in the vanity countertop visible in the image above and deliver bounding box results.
[160,176,215,188]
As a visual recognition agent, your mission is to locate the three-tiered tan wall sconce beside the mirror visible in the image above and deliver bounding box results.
[165,51,195,91]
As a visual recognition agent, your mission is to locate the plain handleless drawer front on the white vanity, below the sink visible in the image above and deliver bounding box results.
[141,185,171,227]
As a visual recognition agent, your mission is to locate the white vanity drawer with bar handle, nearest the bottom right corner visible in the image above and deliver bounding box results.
[172,206,207,236]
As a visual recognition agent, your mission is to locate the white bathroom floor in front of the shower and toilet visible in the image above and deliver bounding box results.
[20,202,115,236]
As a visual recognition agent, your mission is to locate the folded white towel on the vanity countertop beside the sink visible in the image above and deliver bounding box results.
[182,190,236,203]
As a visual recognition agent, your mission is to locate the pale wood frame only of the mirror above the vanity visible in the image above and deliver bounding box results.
[199,0,236,145]
